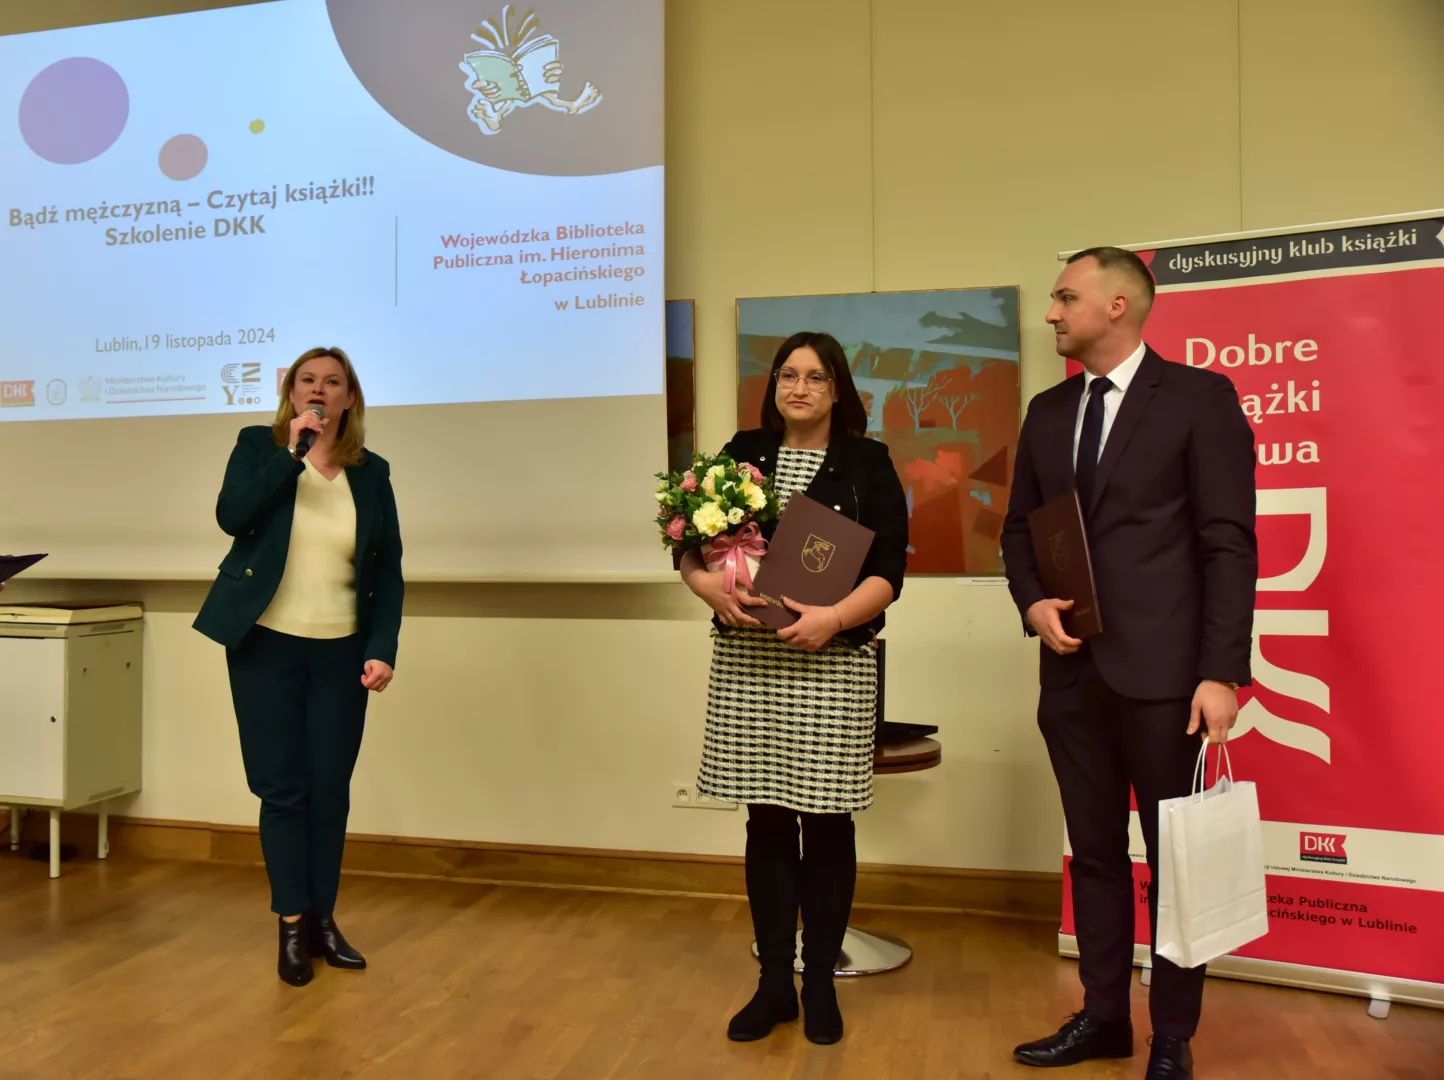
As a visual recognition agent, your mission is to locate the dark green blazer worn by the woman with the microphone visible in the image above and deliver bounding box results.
[193,427,406,667]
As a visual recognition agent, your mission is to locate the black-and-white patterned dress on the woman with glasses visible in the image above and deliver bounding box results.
[697,446,878,813]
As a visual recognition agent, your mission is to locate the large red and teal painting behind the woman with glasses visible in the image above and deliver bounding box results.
[736,286,1022,576]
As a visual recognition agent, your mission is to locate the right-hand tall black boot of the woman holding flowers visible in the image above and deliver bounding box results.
[800,814,858,1044]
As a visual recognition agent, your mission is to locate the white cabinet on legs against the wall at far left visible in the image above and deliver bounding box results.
[0,605,143,878]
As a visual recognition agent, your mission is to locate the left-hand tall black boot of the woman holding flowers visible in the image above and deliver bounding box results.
[726,806,801,1042]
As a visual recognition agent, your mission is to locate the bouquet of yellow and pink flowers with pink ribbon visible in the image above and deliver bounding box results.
[653,453,777,592]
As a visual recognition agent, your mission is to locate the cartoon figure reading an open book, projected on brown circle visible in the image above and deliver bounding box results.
[461,4,602,134]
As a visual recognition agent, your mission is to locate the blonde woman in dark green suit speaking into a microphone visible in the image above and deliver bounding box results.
[195,348,404,986]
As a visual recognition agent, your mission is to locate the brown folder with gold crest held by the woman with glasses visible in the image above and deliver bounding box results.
[747,492,874,630]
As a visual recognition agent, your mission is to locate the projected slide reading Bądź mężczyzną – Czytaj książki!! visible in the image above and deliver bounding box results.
[0,0,664,418]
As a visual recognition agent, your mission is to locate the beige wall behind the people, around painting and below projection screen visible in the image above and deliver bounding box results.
[0,0,1444,871]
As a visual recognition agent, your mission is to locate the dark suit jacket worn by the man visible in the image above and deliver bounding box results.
[1002,349,1259,700]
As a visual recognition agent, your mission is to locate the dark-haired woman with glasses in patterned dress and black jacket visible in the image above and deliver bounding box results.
[682,332,908,1042]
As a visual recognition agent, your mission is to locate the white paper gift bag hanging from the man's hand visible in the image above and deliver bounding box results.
[1155,744,1268,967]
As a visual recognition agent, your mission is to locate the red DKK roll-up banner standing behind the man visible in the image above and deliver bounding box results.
[1061,211,1444,1005]
